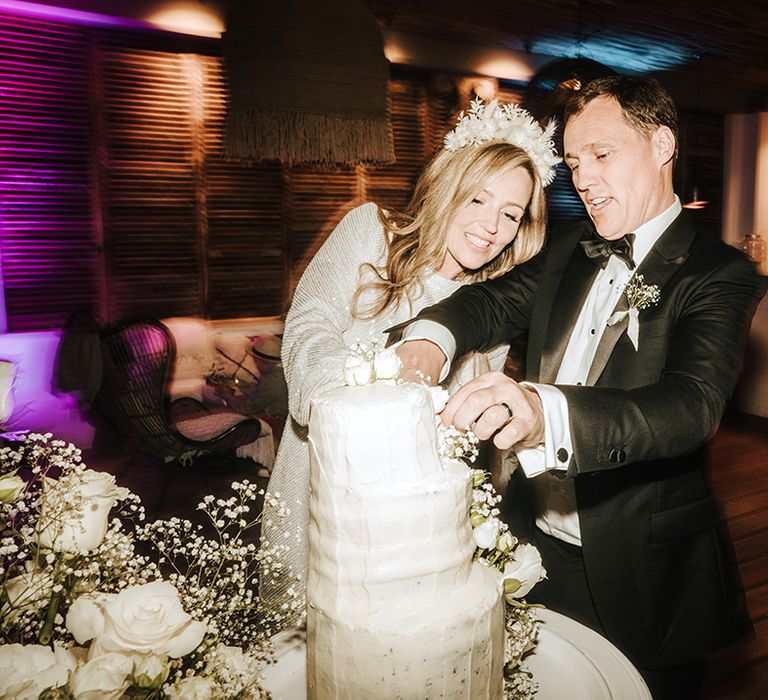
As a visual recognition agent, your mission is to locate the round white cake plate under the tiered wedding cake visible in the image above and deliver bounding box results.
[263,610,651,700]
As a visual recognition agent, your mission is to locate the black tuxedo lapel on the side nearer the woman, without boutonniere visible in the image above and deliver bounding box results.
[538,227,600,384]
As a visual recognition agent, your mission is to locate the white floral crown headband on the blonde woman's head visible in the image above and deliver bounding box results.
[445,98,562,187]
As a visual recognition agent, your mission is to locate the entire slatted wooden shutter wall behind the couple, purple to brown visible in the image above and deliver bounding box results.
[0,15,722,330]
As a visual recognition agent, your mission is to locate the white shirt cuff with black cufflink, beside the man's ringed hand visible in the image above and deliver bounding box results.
[517,382,573,478]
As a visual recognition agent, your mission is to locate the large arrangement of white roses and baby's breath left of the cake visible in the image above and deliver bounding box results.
[0,434,299,700]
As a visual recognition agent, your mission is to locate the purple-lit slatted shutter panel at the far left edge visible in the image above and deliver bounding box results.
[0,15,98,330]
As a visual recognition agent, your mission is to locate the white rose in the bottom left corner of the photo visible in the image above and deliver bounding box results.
[0,644,77,700]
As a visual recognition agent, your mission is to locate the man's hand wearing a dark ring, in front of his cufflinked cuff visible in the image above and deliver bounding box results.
[440,372,544,449]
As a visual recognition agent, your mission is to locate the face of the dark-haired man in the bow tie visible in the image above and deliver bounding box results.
[563,97,671,240]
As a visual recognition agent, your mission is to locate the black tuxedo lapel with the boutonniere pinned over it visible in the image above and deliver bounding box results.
[586,212,696,386]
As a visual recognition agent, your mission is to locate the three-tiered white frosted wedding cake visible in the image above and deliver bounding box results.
[307,382,504,700]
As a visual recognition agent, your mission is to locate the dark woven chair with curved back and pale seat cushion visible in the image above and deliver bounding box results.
[95,320,261,462]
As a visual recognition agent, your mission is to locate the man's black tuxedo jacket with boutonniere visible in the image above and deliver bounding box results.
[408,211,765,668]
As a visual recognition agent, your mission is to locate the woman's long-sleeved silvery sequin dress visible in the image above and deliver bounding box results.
[259,203,508,627]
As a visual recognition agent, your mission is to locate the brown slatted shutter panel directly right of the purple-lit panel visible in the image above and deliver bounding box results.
[95,42,203,318]
